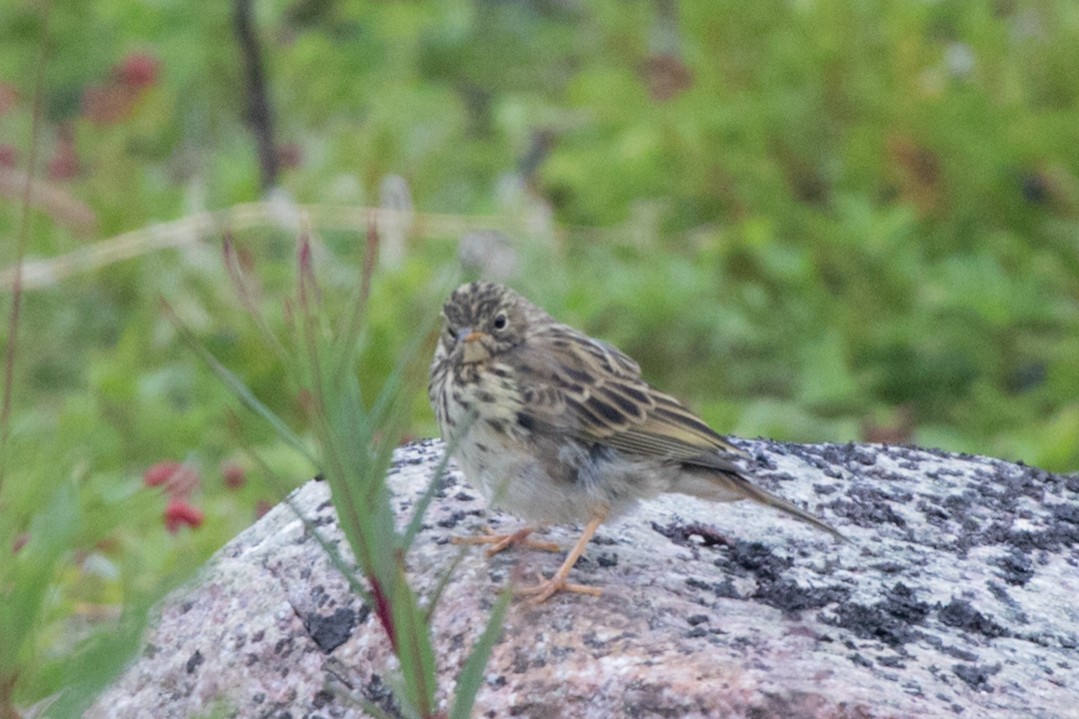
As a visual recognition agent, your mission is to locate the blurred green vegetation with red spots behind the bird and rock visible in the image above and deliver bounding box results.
[0,0,1079,705]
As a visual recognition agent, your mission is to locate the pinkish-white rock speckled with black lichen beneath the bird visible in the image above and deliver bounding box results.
[87,440,1079,719]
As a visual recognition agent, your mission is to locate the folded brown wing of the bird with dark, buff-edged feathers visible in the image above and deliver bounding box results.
[514,325,746,471]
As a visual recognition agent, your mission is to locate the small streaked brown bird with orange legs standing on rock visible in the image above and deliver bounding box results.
[427,282,846,603]
